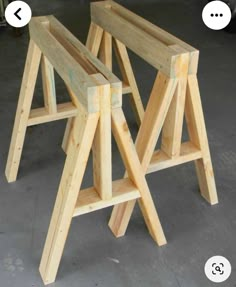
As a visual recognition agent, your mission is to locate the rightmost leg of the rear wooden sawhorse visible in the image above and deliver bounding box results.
[185,75,218,204]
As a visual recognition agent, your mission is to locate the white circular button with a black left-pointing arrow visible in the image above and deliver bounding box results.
[5,1,32,28]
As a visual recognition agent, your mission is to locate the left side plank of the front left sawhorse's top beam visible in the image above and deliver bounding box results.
[29,17,99,113]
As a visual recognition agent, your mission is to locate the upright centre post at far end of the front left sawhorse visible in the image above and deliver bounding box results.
[42,55,57,114]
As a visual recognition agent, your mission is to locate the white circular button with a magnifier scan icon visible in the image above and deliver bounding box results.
[204,256,231,283]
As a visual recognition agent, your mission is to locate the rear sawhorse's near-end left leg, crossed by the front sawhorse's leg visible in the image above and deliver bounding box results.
[110,72,177,236]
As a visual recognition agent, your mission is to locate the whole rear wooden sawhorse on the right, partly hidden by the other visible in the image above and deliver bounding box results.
[87,1,218,236]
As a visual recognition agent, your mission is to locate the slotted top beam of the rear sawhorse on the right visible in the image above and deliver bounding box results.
[91,1,199,78]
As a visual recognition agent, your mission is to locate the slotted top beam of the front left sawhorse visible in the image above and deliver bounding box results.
[29,16,122,113]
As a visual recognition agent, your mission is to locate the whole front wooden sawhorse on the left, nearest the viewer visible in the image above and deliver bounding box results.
[6,16,166,284]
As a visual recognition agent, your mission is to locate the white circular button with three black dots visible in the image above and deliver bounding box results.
[202,1,232,30]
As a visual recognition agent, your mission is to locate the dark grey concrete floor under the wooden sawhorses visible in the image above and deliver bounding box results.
[0,0,236,287]
